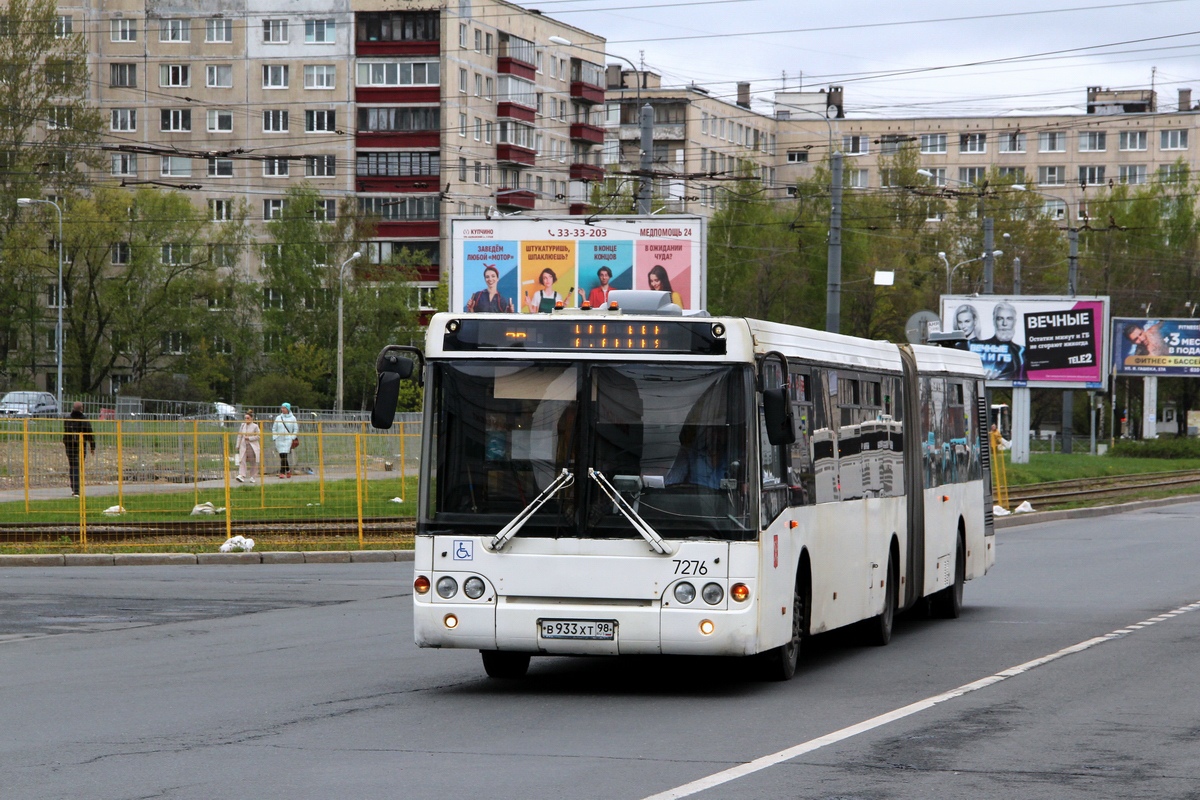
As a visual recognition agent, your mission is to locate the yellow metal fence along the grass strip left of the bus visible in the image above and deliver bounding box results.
[0,414,421,551]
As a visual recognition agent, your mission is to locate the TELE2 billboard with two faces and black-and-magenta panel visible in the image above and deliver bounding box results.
[941,295,1109,389]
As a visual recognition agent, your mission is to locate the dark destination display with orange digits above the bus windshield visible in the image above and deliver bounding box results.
[445,318,725,355]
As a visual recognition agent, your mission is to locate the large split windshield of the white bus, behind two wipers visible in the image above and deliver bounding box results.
[422,361,757,540]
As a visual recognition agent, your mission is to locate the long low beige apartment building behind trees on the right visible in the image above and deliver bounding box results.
[775,86,1200,224]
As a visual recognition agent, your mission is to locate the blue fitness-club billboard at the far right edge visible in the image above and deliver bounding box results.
[1112,317,1200,378]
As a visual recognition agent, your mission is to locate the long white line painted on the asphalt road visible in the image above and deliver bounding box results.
[644,602,1200,800]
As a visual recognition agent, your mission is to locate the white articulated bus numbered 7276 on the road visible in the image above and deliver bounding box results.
[374,303,995,679]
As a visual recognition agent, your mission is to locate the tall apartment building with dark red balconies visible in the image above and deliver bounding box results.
[60,0,605,303]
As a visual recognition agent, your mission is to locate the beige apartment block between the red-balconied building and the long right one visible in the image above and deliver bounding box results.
[604,65,778,217]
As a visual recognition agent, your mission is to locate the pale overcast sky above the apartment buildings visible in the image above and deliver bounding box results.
[532,0,1200,116]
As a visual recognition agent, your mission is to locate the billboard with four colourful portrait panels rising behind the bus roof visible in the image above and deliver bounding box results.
[450,216,707,314]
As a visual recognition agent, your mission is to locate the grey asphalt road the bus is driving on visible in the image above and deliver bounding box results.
[0,504,1200,800]
